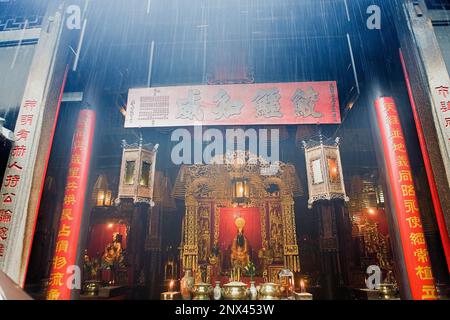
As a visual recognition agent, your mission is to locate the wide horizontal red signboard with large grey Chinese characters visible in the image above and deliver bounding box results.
[125,81,341,128]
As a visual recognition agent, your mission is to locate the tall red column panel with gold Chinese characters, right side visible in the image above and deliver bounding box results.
[375,97,437,300]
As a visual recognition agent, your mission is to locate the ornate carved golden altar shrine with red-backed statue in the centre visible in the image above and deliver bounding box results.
[173,152,303,283]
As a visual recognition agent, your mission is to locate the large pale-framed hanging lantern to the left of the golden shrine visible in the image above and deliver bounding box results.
[118,138,159,206]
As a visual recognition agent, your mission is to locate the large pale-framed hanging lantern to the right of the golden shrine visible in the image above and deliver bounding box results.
[302,134,349,208]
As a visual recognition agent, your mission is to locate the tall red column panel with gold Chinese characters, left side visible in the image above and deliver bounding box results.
[47,110,95,300]
